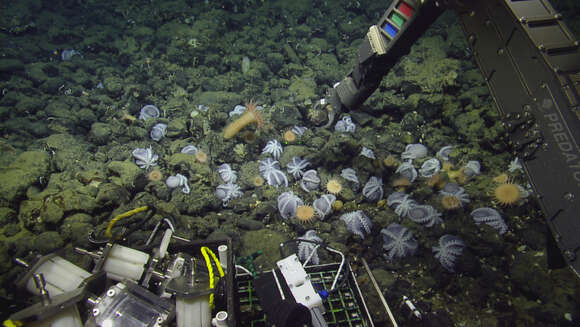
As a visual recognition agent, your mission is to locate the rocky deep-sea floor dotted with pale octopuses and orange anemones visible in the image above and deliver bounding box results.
[0,0,580,326]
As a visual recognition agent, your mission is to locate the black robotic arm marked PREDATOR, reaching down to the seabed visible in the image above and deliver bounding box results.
[326,0,580,276]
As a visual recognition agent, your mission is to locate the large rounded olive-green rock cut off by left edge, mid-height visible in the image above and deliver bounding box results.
[0,151,50,206]
